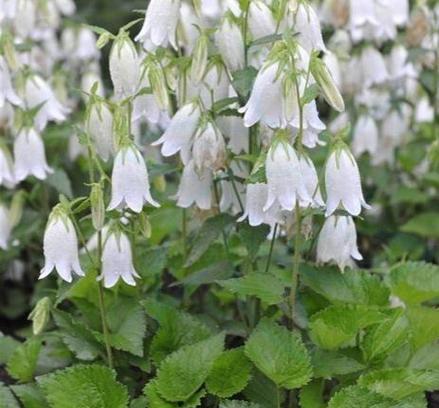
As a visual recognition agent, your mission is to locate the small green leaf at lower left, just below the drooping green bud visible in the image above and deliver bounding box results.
[7,338,41,382]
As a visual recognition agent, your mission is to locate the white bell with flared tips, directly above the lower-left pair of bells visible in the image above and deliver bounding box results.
[108,145,160,213]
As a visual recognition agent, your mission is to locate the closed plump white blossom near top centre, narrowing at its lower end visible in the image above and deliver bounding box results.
[215,16,245,72]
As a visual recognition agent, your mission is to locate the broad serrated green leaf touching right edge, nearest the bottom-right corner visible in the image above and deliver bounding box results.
[358,368,439,400]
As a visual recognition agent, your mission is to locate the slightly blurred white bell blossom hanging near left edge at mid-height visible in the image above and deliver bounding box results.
[14,128,53,181]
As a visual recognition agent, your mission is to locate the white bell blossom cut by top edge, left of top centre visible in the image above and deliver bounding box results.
[136,0,180,49]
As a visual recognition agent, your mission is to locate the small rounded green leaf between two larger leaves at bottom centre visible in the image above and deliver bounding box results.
[206,348,252,398]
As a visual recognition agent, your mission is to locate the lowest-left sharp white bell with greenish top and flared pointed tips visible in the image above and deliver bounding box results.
[39,205,84,282]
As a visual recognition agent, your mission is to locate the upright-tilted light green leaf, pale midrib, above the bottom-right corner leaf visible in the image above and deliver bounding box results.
[361,309,409,362]
